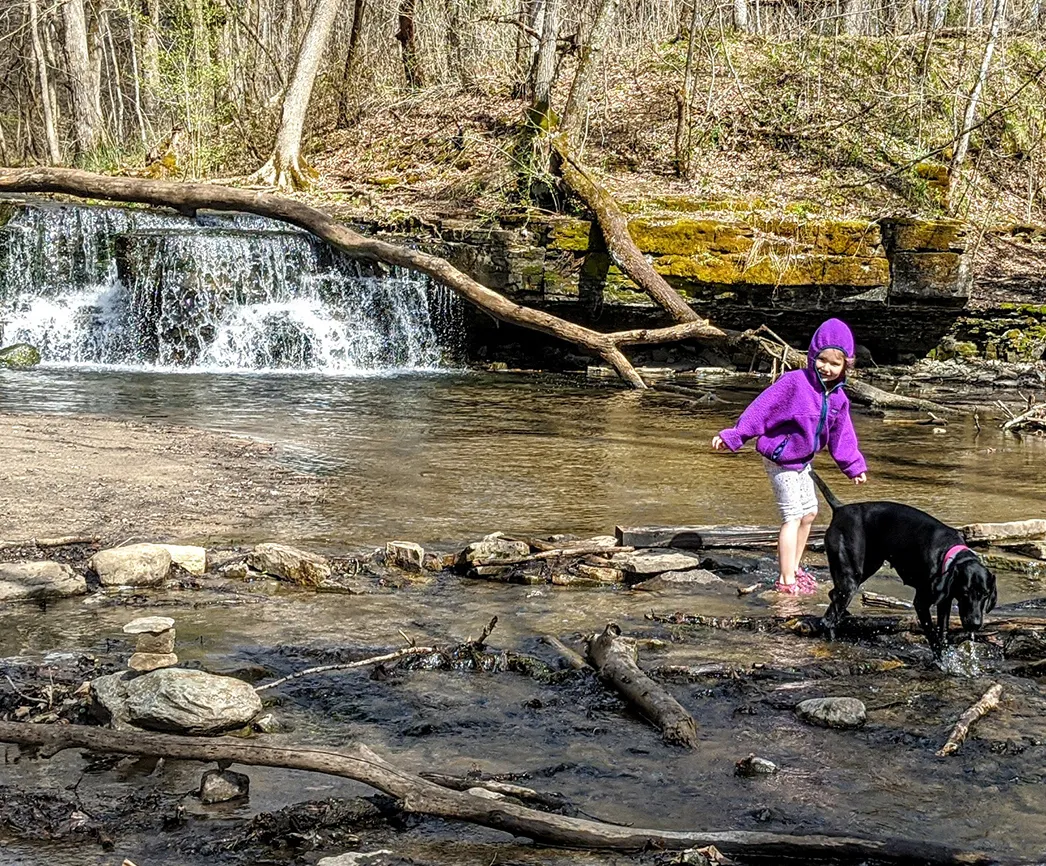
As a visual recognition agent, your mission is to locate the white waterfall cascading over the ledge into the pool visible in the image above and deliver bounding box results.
[0,205,460,374]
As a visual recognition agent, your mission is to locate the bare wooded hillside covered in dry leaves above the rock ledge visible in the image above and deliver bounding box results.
[0,0,1046,233]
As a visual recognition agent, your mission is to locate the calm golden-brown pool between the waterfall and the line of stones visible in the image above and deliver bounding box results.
[0,368,1046,544]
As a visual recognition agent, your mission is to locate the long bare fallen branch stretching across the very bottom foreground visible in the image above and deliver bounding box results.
[0,722,999,866]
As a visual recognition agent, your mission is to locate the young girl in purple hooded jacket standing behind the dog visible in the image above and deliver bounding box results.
[712,319,867,595]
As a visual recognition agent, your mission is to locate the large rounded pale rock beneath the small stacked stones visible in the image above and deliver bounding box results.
[127,667,262,734]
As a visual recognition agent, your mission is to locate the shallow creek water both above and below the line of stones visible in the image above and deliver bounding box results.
[0,369,1046,864]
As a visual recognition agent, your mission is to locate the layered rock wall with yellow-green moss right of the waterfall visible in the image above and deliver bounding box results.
[416,210,972,362]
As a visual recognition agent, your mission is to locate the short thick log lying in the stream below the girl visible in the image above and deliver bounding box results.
[588,622,698,749]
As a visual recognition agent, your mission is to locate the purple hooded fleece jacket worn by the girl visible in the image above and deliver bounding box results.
[720,319,867,478]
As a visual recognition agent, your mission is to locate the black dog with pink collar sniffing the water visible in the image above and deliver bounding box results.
[811,471,998,659]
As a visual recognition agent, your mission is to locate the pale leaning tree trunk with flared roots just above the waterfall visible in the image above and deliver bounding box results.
[251,0,341,189]
